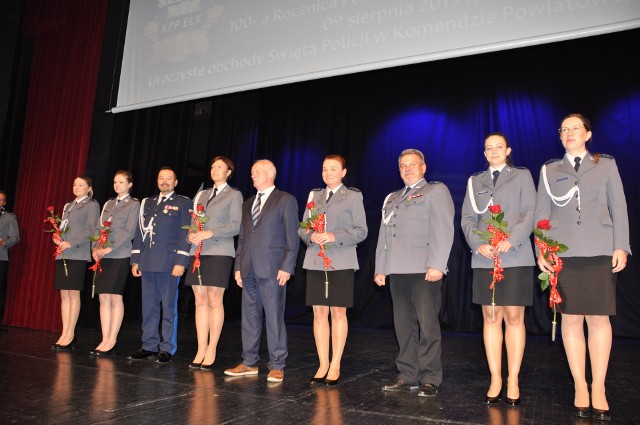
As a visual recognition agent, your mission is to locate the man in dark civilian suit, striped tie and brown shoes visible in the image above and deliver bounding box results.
[224,159,300,382]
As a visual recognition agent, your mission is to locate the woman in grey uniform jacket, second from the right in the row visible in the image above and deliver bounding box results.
[461,133,536,406]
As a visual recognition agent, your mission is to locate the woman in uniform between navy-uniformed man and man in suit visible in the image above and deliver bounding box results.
[185,156,242,370]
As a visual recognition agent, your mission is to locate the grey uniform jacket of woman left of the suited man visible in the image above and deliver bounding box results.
[191,184,242,257]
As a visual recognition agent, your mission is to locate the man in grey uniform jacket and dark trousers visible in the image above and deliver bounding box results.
[374,149,454,397]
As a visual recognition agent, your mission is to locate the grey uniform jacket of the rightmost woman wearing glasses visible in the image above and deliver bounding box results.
[535,152,631,257]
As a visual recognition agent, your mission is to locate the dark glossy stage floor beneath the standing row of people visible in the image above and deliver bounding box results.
[0,321,640,425]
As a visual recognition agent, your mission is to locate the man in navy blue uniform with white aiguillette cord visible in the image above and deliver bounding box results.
[127,167,192,363]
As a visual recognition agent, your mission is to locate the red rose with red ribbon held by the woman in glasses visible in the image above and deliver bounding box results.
[533,220,569,341]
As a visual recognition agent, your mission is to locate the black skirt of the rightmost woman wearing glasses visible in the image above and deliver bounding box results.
[558,255,617,316]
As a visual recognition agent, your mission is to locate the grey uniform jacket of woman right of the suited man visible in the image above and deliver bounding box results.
[298,185,367,270]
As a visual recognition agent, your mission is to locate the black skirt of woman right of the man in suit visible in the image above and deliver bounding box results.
[306,270,355,307]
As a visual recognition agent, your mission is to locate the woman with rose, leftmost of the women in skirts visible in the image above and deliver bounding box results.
[51,176,100,350]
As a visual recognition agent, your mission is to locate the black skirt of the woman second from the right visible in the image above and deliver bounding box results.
[473,266,534,306]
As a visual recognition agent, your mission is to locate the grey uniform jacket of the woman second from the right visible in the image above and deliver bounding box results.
[460,165,536,269]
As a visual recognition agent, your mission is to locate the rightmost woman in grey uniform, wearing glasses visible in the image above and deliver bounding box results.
[535,114,631,420]
